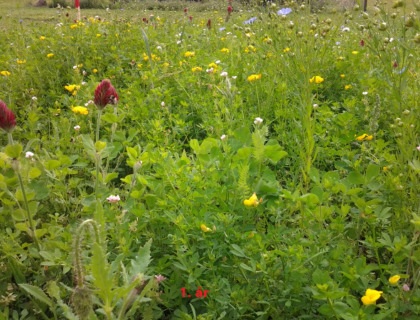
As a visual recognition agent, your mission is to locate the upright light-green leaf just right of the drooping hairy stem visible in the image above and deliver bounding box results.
[92,242,114,303]
